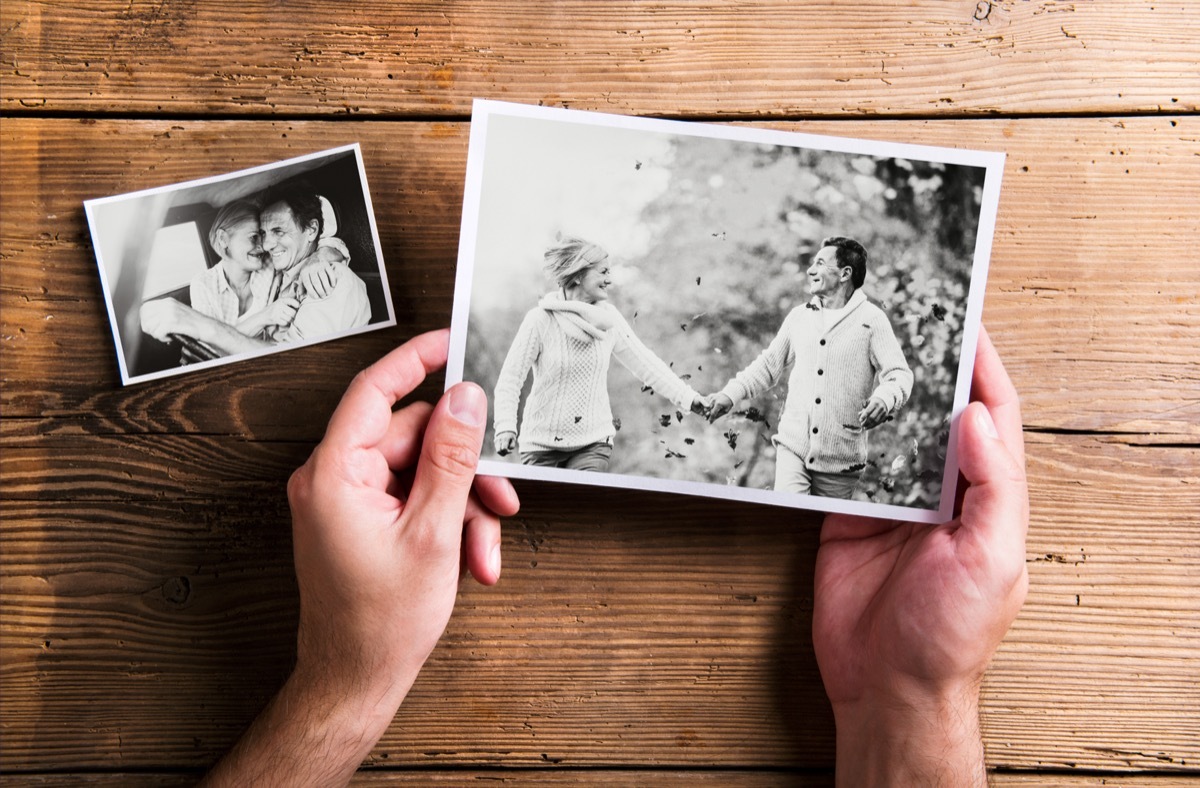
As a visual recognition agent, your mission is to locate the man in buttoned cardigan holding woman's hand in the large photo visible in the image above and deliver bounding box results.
[709,236,912,498]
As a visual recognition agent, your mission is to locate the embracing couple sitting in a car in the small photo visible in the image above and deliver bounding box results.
[140,181,371,360]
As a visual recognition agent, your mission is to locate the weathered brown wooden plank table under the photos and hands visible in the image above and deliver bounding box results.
[0,0,1200,787]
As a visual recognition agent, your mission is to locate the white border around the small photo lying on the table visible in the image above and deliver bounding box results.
[84,143,396,386]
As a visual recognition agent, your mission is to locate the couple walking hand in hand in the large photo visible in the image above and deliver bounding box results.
[493,237,913,498]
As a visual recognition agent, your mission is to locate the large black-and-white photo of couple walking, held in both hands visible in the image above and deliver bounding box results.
[446,101,1003,522]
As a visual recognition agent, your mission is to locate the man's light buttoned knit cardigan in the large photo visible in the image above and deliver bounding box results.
[721,290,912,473]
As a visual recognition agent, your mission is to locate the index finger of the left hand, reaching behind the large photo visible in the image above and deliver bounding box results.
[325,329,450,447]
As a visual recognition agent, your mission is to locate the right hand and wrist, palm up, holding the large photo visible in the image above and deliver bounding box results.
[812,323,1028,786]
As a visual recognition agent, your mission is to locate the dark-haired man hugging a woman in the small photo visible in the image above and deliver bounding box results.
[140,182,371,355]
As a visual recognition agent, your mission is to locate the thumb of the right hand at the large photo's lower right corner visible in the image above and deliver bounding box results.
[959,402,1030,546]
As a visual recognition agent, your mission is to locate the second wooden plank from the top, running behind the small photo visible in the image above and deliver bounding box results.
[0,118,1200,440]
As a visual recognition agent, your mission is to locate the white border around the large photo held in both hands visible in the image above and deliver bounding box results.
[445,98,1004,523]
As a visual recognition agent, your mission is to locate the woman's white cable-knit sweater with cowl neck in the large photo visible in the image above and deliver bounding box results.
[493,293,698,453]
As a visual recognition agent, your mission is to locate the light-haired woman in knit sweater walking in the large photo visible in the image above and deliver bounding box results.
[493,237,708,471]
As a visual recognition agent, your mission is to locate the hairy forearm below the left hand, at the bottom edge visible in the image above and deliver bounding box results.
[202,668,412,788]
